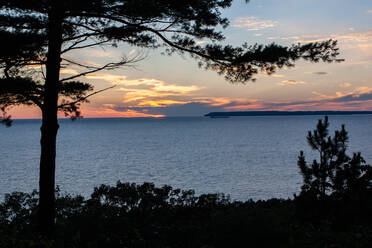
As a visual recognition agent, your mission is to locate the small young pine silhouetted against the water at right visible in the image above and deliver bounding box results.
[298,116,372,200]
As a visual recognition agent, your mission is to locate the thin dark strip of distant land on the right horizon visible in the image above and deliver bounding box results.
[204,111,372,118]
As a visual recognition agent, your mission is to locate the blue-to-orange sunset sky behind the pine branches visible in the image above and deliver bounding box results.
[10,0,372,118]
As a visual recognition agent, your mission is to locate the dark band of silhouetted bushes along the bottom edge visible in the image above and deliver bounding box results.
[0,182,372,248]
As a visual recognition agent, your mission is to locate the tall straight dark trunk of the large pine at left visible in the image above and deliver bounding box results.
[39,6,63,238]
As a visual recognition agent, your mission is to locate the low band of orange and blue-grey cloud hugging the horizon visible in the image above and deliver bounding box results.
[90,86,372,117]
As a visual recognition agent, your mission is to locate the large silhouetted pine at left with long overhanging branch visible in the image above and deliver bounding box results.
[0,0,338,235]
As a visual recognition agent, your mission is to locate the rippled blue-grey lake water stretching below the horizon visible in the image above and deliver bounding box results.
[0,115,372,200]
